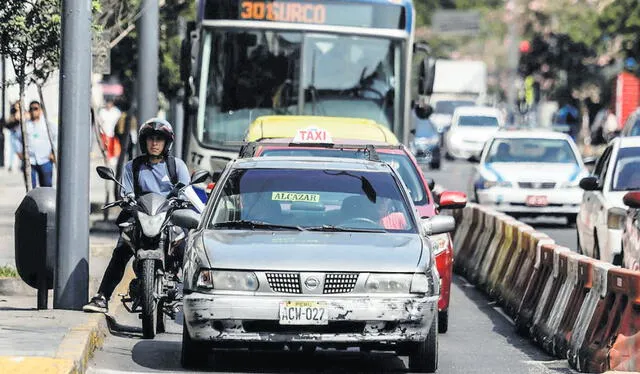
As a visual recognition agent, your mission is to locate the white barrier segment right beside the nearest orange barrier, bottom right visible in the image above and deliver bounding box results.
[567,261,615,371]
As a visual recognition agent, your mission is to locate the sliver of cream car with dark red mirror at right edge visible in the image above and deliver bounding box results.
[622,191,640,271]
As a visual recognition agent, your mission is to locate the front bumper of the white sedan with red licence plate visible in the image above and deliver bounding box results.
[477,187,583,215]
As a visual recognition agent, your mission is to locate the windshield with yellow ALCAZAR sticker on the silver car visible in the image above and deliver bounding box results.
[207,169,416,232]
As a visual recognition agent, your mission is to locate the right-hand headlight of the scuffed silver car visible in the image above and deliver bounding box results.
[364,273,433,293]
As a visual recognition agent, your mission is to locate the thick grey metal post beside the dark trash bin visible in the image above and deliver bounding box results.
[53,0,91,310]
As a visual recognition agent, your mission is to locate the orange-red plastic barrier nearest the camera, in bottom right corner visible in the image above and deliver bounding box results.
[578,267,640,372]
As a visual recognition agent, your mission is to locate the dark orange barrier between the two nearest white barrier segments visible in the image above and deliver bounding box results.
[553,255,598,358]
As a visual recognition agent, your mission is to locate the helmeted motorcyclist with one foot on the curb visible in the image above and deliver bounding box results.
[82,118,190,313]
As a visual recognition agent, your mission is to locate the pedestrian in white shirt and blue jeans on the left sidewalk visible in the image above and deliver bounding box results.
[14,100,58,187]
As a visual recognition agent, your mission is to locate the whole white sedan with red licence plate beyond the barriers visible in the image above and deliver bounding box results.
[470,130,589,224]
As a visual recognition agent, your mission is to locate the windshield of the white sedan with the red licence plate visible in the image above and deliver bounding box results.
[486,138,578,164]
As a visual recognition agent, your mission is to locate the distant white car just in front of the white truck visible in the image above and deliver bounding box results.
[445,106,504,159]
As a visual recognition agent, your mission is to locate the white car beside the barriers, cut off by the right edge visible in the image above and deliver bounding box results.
[577,136,640,265]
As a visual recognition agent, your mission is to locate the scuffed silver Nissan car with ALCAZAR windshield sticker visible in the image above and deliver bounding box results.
[182,157,455,372]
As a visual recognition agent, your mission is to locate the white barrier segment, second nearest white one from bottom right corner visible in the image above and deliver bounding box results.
[531,245,570,345]
